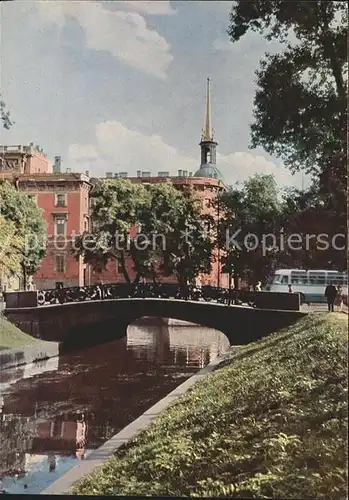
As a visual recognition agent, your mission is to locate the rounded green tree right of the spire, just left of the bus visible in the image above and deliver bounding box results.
[217,174,281,286]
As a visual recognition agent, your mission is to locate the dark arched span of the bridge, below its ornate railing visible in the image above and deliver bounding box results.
[5,298,304,345]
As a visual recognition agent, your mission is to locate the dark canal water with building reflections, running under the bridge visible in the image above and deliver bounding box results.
[0,320,229,494]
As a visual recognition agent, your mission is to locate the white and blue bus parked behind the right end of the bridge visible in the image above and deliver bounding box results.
[269,269,348,302]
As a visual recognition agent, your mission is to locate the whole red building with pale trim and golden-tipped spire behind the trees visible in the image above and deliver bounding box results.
[0,80,228,291]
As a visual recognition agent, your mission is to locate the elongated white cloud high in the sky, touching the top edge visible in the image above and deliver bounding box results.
[35,0,173,79]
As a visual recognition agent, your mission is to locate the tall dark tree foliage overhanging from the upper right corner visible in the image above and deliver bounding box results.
[229,0,348,227]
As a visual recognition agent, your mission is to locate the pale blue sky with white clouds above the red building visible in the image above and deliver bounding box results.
[0,0,308,187]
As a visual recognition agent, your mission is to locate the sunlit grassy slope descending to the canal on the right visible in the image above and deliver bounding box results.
[74,313,348,500]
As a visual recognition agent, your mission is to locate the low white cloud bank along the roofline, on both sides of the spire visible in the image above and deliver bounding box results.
[67,121,299,186]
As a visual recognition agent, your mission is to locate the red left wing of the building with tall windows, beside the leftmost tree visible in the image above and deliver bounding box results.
[0,146,91,289]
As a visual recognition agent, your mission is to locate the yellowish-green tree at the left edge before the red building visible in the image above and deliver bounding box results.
[0,182,47,288]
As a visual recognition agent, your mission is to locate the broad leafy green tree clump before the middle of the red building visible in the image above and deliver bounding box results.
[76,180,213,283]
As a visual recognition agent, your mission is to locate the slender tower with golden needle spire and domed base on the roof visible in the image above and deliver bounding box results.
[194,78,223,180]
